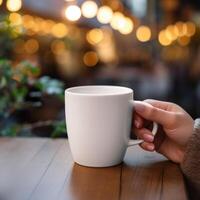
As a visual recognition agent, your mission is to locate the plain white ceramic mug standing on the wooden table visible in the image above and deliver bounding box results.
[65,86,158,167]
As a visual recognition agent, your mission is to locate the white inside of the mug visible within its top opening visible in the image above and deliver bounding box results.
[66,86,133,95]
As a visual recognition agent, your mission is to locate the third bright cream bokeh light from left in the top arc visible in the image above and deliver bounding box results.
[97,6,113,24]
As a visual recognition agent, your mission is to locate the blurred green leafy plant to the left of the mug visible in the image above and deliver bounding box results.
[0,59,65,137]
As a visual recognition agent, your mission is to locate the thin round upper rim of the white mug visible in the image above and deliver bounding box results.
[65,85,133,96]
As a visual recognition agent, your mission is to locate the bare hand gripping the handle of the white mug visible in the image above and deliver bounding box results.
[134,100,194,163]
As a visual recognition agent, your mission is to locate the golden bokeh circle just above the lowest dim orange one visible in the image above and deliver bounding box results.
[86,28,104,45]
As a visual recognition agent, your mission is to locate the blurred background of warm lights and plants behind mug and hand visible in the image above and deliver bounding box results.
[0,0,200,137]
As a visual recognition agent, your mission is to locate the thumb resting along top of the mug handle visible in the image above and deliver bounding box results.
[134,101,174,128]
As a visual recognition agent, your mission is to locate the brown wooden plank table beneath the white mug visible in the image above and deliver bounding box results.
[0,138,187,200]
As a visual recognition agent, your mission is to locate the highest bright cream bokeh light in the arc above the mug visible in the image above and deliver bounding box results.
[81,1,98,18]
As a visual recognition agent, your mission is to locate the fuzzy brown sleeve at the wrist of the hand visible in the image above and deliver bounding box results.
[181,119,200,200]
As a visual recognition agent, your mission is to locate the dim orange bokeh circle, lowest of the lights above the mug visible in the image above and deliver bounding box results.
[83,51,99,67]
